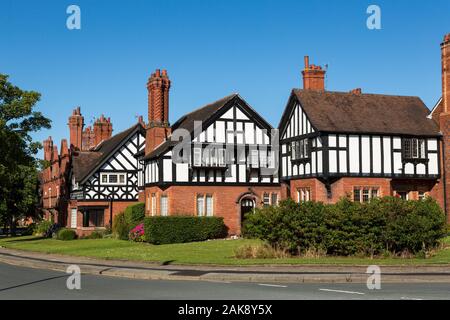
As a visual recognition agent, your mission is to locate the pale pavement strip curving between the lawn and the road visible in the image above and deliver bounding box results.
[0,248,450,285]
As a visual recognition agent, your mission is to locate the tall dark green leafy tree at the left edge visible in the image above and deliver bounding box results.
[0,74,51,234]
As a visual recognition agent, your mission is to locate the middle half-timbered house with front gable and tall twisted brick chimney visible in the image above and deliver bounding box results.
[141,70,285,235]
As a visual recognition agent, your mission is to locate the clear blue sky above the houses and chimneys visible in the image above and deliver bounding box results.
[0,0,450,156]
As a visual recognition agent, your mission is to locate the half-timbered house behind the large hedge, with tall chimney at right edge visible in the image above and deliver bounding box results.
[279,35,450,220]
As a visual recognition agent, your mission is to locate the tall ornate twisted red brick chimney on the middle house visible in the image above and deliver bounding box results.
[145,69,171,154]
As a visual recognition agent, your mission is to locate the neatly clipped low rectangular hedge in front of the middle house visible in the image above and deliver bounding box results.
[144,216,227,244]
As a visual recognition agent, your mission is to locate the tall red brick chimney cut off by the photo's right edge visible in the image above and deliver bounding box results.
[439,34,450,222]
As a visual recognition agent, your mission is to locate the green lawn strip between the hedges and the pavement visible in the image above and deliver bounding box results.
[0,236,450,265]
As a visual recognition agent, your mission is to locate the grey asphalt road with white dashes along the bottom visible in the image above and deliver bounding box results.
[0,264,450,300]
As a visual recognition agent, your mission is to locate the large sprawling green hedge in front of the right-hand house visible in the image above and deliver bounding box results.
[243,197,446,256]
